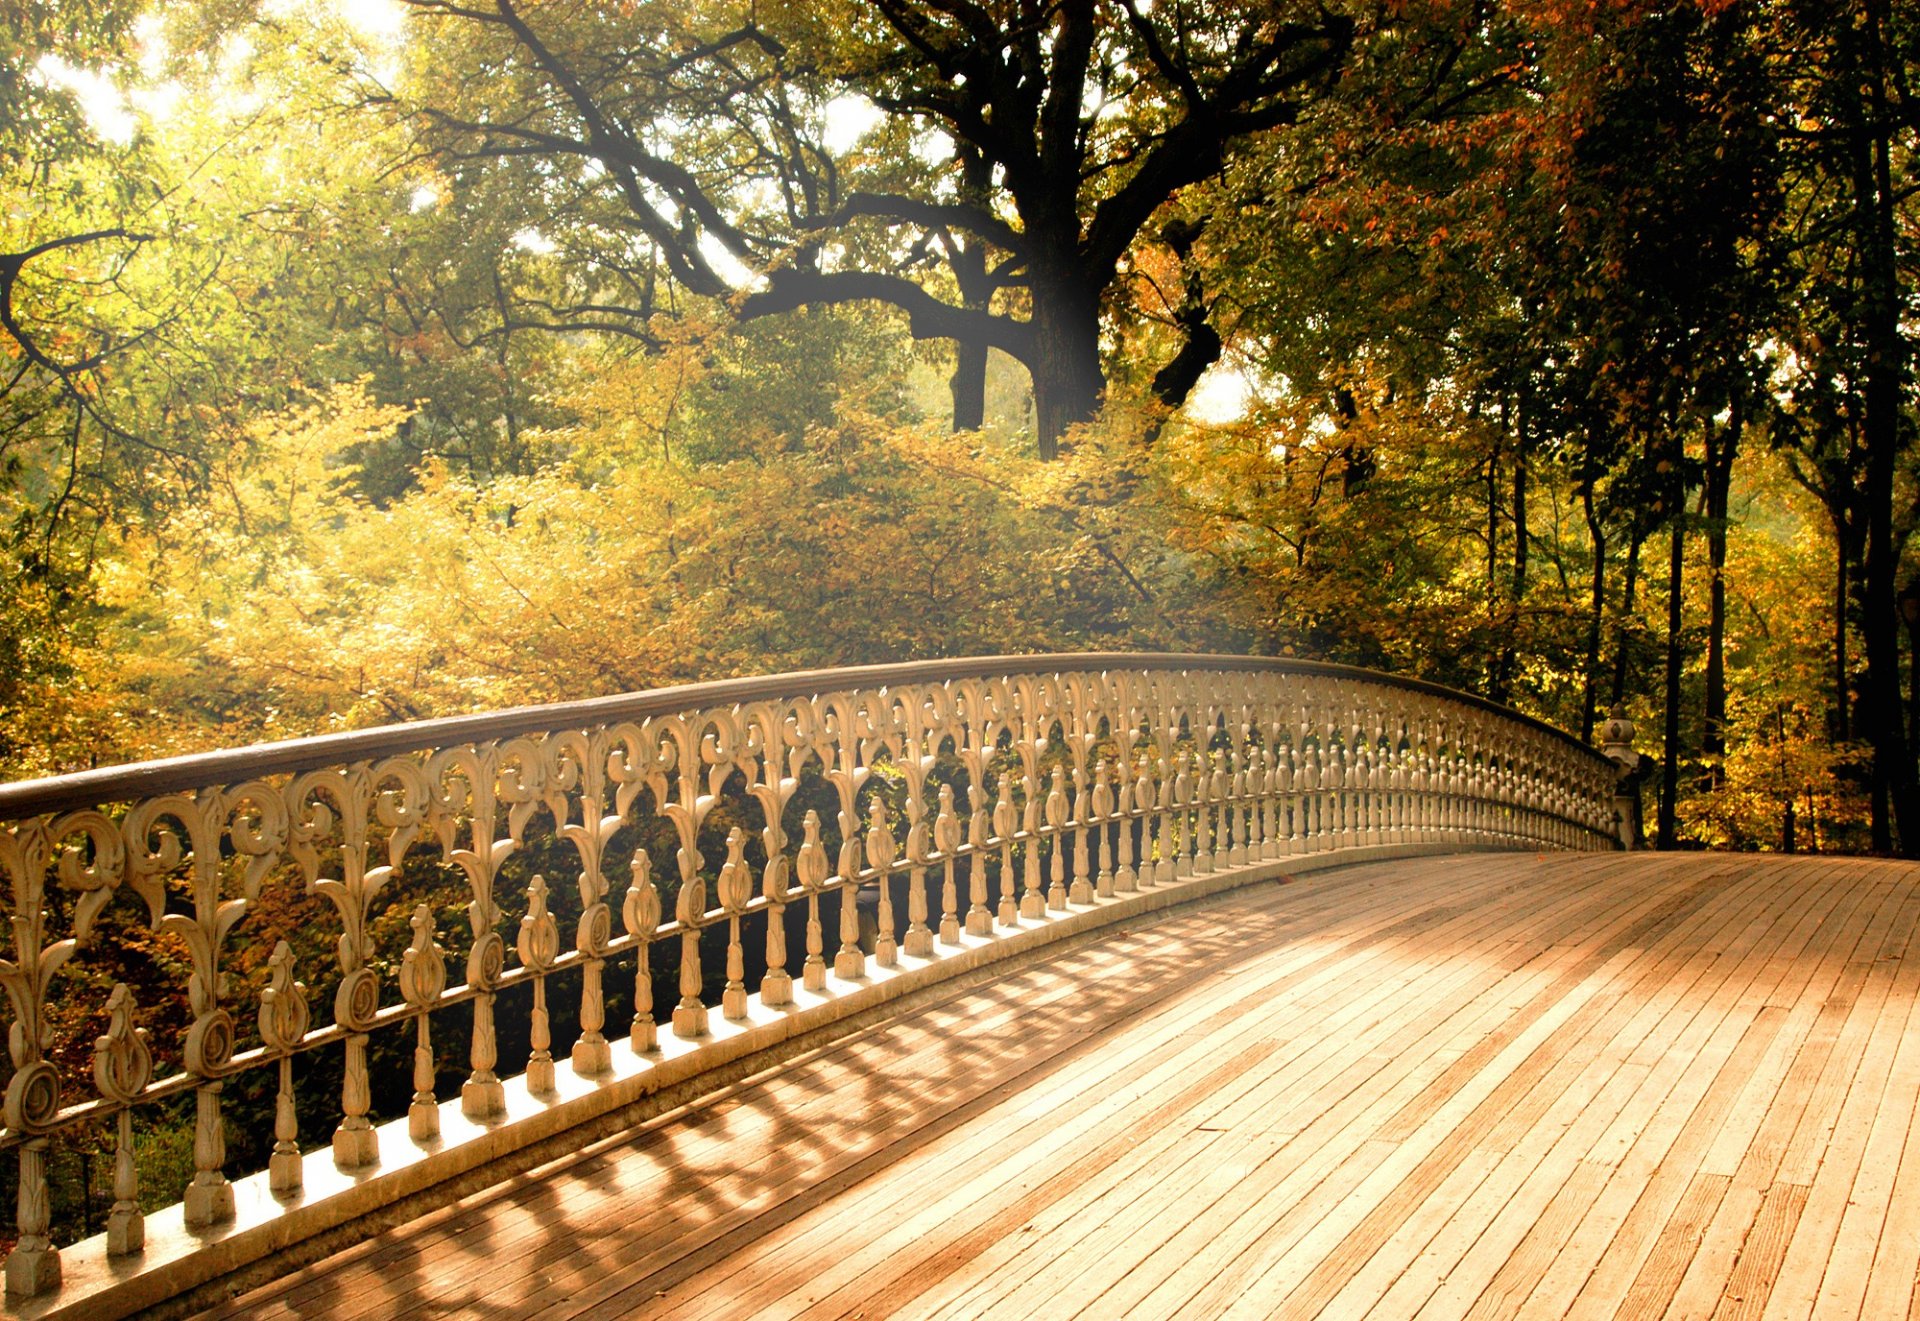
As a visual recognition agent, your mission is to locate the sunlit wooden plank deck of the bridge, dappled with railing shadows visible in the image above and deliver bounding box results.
[206,854,1920,1321]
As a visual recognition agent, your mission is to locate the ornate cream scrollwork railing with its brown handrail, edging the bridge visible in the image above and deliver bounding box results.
[0,655,1615,1317]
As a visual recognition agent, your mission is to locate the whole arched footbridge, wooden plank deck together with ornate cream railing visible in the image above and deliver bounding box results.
[0,655,1920,1317]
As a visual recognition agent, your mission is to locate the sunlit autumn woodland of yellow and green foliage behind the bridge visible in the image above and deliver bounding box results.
[0,0,1920,854]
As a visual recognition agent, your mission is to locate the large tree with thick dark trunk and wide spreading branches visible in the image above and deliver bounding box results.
[376,0,1356,455]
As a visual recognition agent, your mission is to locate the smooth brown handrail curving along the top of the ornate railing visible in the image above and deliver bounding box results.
[0,651,1607,822]
